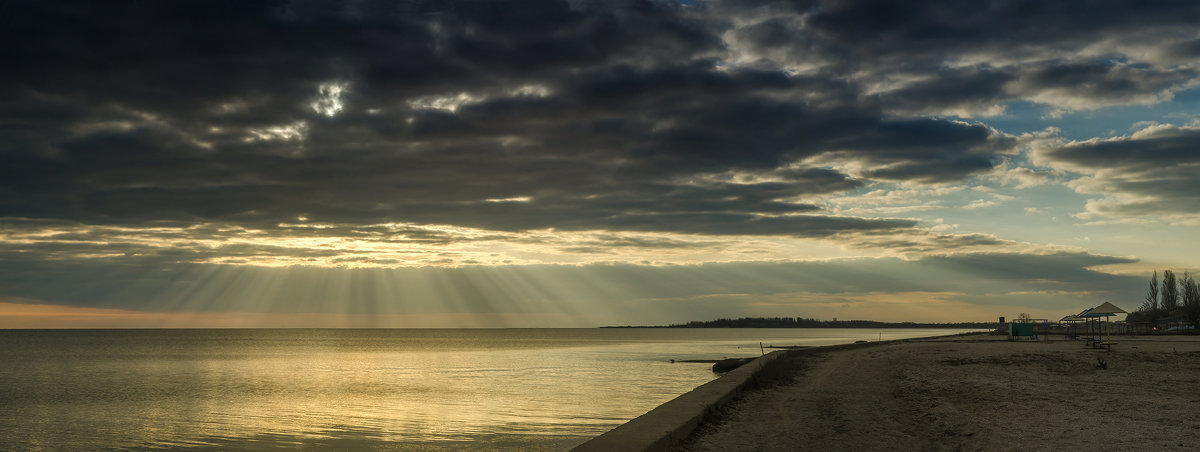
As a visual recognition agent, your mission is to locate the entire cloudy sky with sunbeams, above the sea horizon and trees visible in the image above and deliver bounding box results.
[0,0,1200,327]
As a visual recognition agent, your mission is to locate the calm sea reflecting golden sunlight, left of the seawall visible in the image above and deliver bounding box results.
[0,329,974,451]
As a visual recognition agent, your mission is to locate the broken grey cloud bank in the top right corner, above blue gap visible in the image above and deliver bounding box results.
[722,0,1200,115]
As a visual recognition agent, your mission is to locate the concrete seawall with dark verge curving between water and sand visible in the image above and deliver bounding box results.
[571,332,990,452]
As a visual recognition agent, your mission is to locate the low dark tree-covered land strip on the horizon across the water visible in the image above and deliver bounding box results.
[601,317,997,330]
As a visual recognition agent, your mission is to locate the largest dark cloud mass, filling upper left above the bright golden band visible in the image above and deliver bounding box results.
[0,1,1032,236]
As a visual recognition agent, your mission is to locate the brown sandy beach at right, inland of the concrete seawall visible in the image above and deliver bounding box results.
[680,336,1200,451]
